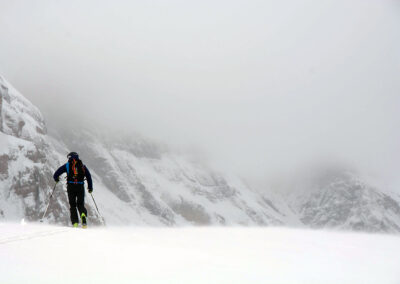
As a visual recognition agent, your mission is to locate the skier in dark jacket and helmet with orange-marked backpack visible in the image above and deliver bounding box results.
[53,152,93,228]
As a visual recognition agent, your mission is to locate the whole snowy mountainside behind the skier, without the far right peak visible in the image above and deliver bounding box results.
[0,77,283,226]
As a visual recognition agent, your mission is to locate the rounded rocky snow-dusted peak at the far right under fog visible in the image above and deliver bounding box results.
[291,172,400,232]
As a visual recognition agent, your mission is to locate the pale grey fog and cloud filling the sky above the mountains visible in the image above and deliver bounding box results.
[0,0,400,188]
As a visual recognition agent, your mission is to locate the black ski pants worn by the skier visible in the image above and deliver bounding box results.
[67,183,87,224]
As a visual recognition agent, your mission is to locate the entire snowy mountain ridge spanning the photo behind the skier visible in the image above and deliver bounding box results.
[0,77,400,232]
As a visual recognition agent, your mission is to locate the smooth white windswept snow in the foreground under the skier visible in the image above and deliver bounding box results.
[0,223,400,284]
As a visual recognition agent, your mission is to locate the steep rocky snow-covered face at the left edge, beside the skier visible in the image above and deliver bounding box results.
[0,77,67,222]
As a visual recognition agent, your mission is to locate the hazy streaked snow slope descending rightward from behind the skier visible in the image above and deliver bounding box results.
[54,131,283,226]
